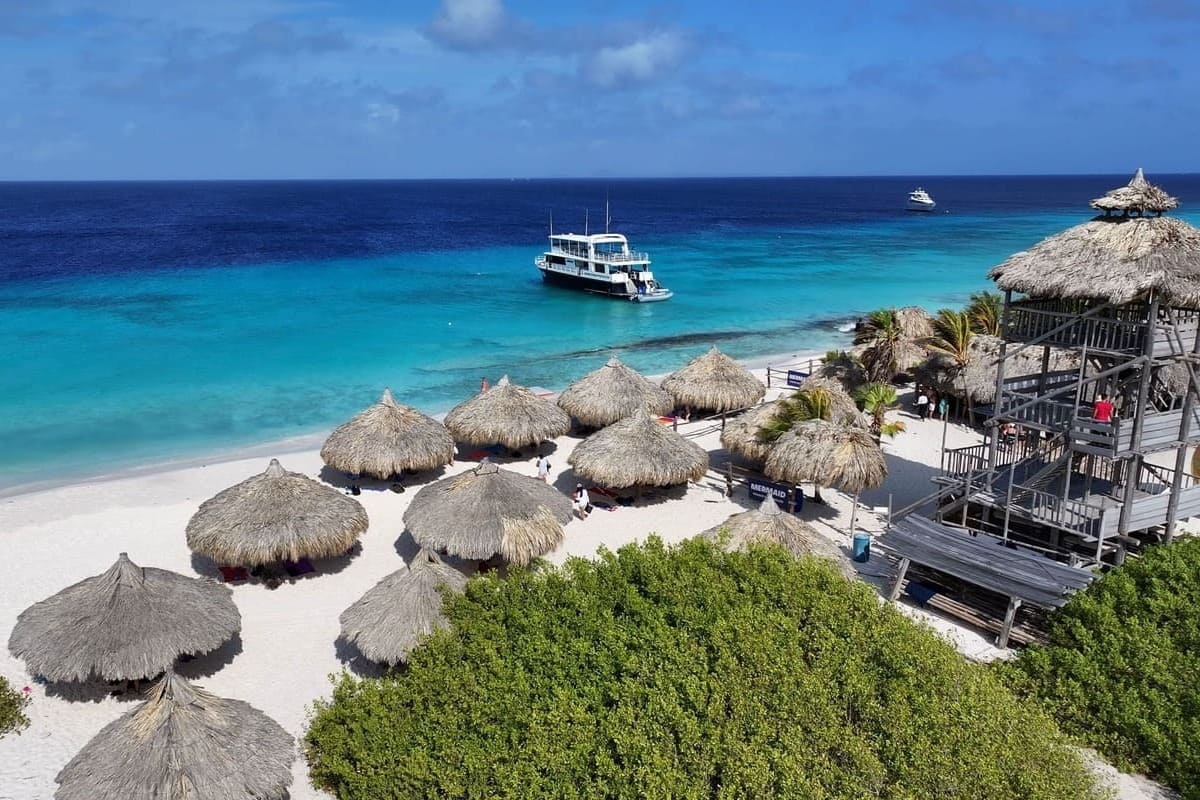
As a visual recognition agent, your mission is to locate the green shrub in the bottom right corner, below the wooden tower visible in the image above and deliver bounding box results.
[1002,539,1200,800]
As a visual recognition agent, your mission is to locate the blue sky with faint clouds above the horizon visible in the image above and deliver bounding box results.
[0,0,1200,179]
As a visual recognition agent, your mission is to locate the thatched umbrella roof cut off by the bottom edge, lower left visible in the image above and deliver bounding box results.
[54,672,295,800]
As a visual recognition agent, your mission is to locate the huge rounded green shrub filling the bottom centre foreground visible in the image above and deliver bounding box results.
[305,539,1093,800]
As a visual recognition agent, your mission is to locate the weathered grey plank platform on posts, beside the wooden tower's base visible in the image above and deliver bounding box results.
[877,515,1096,648]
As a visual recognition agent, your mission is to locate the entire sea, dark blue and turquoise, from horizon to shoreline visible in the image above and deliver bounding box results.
[0,175,1200,489]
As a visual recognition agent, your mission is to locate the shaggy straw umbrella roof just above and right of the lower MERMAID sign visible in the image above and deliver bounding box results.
[764,420,888,492]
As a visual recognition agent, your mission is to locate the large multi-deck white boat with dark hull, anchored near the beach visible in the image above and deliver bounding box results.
[534,233,674,302]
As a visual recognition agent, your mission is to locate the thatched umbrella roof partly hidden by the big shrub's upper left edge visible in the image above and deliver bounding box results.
[338,548,467,664]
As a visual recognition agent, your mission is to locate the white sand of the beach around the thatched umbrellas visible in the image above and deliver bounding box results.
[0,364,1169,800]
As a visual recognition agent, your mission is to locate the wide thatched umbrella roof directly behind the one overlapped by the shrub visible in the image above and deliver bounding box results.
[404,460,571,565]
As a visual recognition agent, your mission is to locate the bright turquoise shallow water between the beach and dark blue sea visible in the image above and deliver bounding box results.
[0,178,1200,488]
